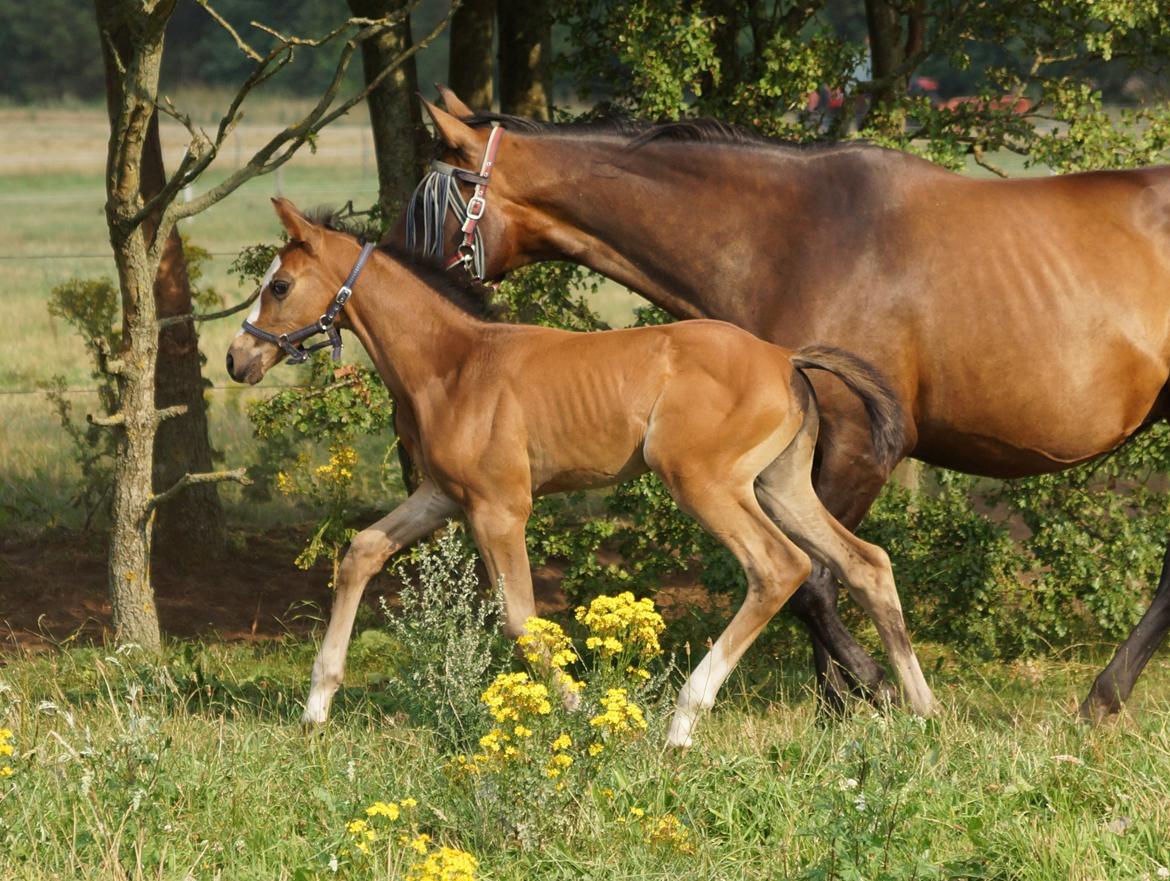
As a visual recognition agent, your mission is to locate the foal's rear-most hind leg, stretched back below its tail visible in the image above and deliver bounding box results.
[756,431,934,716]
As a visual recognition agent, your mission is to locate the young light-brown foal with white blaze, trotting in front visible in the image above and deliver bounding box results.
[227,200,932,746]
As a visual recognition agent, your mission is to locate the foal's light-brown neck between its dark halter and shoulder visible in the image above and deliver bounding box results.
[346,255,482,402]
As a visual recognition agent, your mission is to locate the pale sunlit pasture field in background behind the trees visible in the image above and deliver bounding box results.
[0,102,636,528]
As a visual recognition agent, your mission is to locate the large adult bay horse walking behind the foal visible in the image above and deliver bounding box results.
[395,90,1170,718]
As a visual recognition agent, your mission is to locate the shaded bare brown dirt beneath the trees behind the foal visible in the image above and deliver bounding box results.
[0,521,722,654]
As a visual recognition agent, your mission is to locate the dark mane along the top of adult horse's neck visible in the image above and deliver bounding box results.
[462,112,865,151]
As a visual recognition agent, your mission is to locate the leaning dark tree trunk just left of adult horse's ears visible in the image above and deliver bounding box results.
[349,0,429,222]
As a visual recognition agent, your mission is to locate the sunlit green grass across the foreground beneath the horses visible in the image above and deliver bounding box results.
[0,643,1170,881]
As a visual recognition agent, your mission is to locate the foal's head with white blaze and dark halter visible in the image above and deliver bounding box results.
[227,199,358,385]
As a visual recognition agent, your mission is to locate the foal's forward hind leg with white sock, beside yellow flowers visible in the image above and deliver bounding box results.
[662,474,811,748]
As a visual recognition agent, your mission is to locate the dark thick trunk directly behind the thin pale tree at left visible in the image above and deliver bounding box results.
[143,113,227,559]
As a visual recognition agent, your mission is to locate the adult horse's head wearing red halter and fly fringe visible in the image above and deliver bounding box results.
[395,88,523,281]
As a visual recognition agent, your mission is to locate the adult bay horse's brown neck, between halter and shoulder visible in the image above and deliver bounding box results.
[521,138,903,322]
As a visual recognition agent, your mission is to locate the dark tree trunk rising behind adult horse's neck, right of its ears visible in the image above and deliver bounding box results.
[500,0,552,119]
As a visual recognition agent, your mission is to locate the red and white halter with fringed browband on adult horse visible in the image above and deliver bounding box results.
[406,125,504,281]
